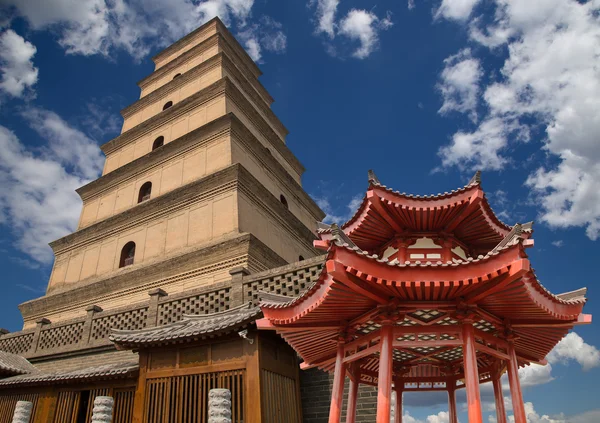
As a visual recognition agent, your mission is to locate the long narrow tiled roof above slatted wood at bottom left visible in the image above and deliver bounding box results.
[0,361,139,386]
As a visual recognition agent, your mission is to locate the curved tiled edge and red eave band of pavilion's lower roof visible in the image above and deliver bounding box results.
[260,232,585,324]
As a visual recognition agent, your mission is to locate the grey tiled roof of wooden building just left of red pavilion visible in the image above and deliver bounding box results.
[110,303,261,348]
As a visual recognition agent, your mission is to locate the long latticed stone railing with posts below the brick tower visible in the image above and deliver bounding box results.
[0,257,323,358]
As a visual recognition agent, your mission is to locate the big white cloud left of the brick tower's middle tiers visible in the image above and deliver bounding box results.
[0,109,102,264]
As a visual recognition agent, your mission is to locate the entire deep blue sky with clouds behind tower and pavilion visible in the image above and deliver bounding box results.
[0,0,600,423]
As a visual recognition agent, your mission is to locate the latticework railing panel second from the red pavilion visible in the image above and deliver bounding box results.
[158,288,230,326]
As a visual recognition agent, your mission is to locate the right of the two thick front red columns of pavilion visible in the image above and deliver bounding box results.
[462,320,486,423]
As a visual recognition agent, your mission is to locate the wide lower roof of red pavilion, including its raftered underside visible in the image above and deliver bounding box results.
[259,224,588,376]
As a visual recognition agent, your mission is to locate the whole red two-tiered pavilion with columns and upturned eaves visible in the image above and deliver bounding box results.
[257,172,591,423]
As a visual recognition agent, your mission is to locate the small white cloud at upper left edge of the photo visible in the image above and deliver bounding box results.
[0,29,38,97]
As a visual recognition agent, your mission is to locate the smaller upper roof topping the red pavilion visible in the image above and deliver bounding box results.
[318,171,512,252]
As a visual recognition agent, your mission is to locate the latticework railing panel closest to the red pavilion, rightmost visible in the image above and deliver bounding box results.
[244,264,323,304]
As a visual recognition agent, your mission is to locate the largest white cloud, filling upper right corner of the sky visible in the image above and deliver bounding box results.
[436,0,600,239]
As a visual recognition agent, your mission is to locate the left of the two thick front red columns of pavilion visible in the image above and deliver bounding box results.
[376,321,394,423]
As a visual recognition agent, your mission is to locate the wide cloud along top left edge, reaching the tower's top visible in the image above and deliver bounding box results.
[5,0,282,59]
